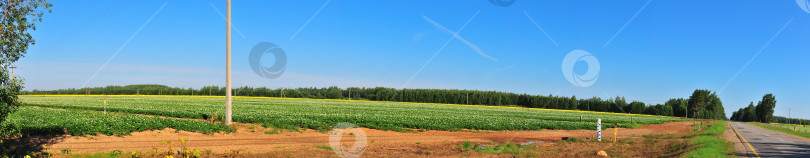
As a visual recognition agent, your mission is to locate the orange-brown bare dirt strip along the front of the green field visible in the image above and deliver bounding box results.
[38,122,692,157]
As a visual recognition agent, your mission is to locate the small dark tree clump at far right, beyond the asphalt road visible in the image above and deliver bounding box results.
[731,93,786,123]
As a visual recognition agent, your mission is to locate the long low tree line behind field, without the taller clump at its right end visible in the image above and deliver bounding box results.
[24,84,669,116]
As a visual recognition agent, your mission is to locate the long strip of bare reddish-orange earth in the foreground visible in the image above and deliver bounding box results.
[30,122,691,157]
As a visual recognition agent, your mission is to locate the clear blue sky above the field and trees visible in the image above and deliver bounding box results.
[16,0,810,118]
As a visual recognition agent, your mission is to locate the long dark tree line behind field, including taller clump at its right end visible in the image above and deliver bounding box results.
[24,84,726,119]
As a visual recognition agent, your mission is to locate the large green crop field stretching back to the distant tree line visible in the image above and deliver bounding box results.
[11,96,680,135]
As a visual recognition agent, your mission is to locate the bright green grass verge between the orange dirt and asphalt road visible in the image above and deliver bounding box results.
[679,120,734,158]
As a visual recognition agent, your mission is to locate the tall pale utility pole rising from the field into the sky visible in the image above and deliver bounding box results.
[225,0,233,125]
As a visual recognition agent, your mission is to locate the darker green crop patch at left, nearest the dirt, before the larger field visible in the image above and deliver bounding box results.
[3,107,235,136]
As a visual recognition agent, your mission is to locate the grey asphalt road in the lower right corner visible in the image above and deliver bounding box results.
[731,122,810,158]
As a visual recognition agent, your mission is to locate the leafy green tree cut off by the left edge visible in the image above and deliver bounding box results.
[0,0,52,126]
